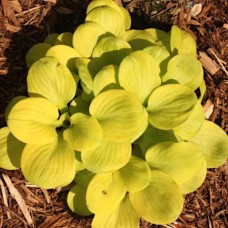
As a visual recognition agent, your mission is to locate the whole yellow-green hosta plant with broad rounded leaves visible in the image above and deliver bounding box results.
[0,0,228,228]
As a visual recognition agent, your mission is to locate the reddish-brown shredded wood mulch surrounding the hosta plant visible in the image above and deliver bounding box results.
[0,0,228,228]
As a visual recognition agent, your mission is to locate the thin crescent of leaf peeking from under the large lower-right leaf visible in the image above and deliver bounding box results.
[179,161,207,194]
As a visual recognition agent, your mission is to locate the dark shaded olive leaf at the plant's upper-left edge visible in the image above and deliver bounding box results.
[25,43,52,67]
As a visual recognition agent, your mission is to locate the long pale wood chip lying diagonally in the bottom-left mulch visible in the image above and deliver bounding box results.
[2,174,33,225]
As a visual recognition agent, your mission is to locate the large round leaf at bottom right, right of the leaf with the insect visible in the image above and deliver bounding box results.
[129,170,183,225]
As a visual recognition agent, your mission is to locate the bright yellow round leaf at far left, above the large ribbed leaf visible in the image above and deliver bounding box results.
[7,97,60,144]
